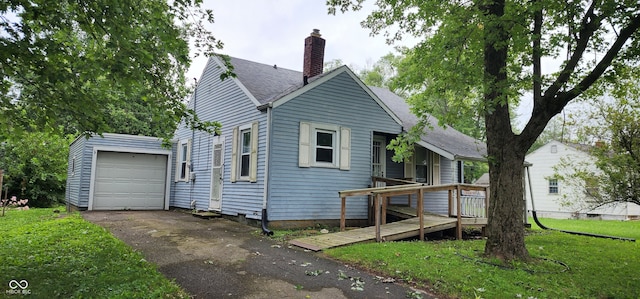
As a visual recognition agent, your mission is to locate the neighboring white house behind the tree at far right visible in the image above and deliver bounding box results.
[525,140,640,220]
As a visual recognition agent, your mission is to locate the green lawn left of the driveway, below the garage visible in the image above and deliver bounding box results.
[0,209,188,298]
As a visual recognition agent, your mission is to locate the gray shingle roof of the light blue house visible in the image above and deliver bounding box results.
[231,57,486,160]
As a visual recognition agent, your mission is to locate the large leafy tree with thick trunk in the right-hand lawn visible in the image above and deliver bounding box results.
[328,0,640,259]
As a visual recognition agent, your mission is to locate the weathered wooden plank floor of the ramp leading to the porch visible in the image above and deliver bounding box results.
[289,215,457,251]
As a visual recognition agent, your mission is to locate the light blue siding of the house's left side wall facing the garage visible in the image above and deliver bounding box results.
[170,58,267,219]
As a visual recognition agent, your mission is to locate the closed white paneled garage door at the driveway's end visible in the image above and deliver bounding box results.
[92,151,167,210]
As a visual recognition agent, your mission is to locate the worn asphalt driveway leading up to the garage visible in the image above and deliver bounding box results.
[82,211,431,298]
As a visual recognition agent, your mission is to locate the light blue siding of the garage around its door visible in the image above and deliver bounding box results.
[66,134,166,210]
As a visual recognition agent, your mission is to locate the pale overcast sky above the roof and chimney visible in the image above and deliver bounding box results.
[187,0,576,129]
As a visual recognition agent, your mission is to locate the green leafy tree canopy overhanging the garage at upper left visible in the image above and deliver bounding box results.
[0,0,222,137]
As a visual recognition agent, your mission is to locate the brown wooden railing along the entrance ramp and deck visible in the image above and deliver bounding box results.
[338,177,489,242]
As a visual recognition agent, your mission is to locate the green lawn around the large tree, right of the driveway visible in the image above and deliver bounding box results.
[326,219,640,298]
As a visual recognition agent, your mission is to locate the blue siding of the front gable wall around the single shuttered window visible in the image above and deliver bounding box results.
[268,73,402,220]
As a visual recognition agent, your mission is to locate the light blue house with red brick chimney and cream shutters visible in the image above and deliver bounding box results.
[70,31,486,230]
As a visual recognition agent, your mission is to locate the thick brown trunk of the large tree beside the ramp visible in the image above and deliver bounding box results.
[482,0,529,260]
